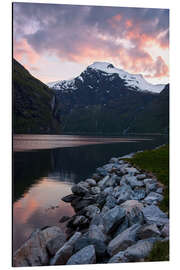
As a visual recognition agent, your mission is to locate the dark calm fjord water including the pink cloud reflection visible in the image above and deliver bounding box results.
[13,135,168,251]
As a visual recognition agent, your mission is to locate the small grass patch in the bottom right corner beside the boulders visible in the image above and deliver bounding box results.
[145,241,169,262]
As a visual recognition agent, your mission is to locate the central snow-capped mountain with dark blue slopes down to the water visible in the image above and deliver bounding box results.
[48,62,169,134]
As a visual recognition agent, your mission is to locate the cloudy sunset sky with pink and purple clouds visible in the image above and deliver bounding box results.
[13,3,169,84]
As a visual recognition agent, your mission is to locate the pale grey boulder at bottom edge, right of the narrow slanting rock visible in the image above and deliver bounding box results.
[67,245,96,265]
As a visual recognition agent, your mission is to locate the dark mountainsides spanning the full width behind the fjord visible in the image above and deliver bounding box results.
[13,60,169,134]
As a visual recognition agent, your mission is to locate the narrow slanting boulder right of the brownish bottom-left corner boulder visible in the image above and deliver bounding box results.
[50,232,82,265]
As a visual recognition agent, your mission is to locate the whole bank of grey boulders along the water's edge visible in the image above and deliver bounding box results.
[13,155,169,266]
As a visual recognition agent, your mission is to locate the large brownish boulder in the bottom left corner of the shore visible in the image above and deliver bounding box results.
[13,226,65,267]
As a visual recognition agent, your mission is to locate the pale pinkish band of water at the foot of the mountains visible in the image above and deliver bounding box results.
[13,134,151,152]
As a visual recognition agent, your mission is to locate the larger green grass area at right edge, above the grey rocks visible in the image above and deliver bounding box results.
[125,145,169,213]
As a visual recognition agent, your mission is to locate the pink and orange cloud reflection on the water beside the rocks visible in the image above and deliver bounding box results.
[13,178,74,250]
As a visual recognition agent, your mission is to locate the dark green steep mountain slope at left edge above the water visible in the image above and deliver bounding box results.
[13,59,60,134]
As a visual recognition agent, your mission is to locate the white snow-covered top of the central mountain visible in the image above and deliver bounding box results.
[47,62,165,93]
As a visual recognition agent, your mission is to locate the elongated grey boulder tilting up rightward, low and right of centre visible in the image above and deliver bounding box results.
[107,224,141,256]
